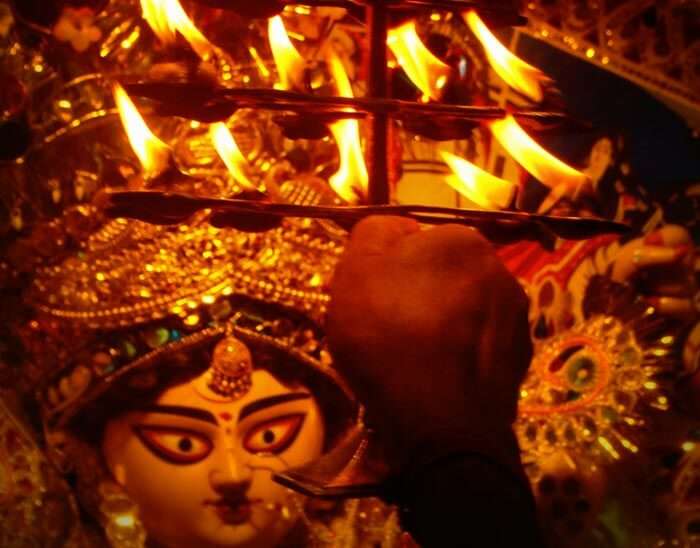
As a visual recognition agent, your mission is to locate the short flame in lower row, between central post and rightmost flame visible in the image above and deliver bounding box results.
[440,150,515,209]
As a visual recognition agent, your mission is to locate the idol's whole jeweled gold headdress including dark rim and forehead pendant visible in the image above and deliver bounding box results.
[23,212,349,426]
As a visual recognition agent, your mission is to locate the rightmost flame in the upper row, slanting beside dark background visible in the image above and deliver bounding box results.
[462,10,548,103]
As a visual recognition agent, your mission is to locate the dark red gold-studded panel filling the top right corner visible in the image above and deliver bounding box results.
[523,0,700,124]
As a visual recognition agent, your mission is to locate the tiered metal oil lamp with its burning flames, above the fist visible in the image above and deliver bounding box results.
[105,0,624,244]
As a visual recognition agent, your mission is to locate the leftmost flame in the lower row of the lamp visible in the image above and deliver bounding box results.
[112,84,170,177]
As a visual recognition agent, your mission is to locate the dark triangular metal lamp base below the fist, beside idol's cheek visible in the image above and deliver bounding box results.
[274,423,391,499]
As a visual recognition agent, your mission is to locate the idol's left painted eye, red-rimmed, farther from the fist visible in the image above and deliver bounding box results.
[134,424,214,464]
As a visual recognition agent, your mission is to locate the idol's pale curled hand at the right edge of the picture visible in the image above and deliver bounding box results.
[611,225,696,320]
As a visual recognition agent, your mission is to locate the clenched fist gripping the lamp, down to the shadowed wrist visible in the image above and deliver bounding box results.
[327,217,532,469]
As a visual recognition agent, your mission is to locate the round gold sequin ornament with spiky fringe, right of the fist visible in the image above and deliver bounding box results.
[516,314,669,462]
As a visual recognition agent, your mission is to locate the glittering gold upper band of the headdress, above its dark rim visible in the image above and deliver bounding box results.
[30,213,342,328]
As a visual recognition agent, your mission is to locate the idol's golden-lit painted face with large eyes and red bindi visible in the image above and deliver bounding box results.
[102,341,324,548]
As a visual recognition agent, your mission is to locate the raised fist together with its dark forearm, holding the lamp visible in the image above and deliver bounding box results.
[327,217,542,548]
